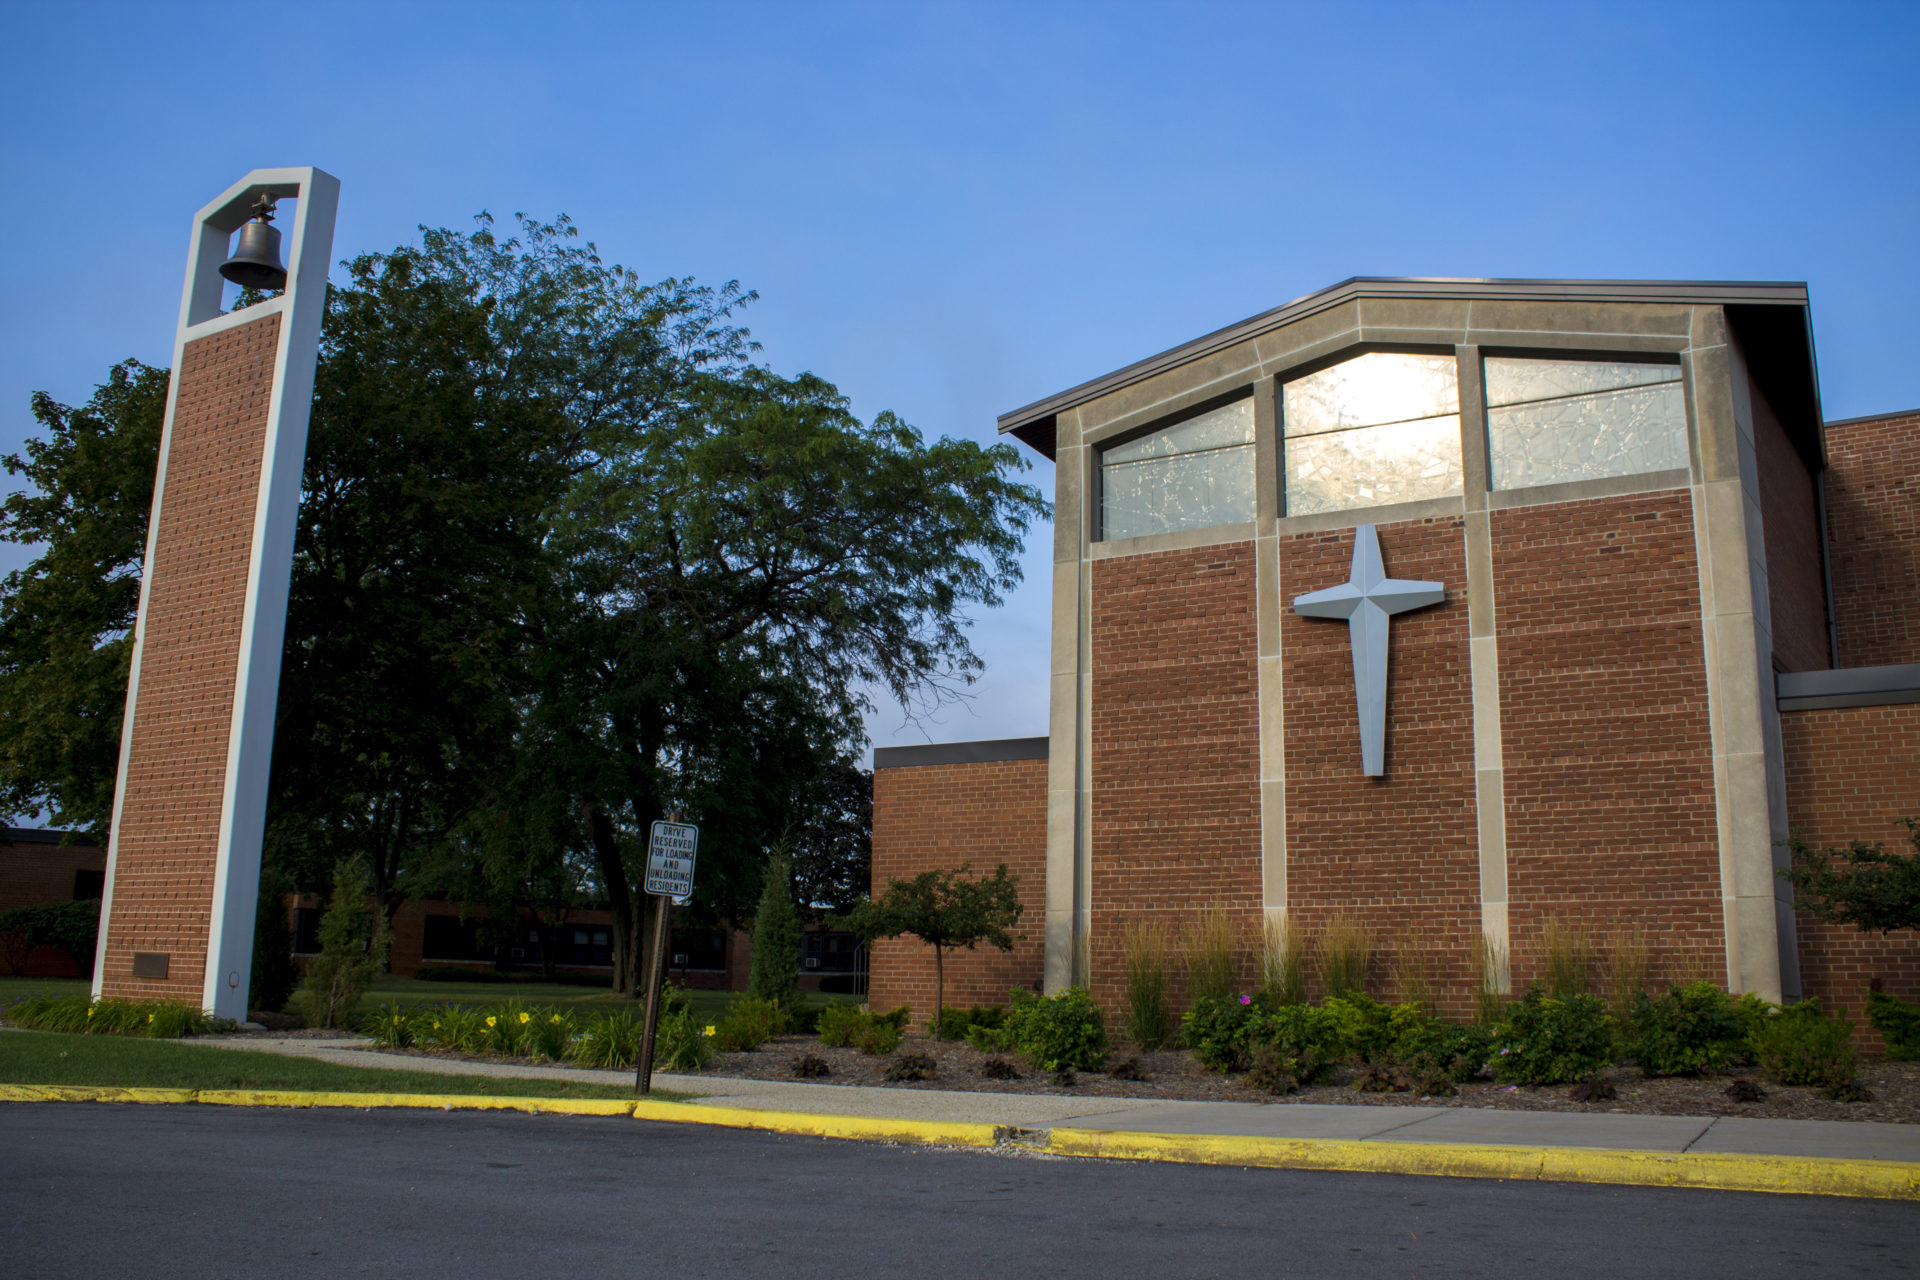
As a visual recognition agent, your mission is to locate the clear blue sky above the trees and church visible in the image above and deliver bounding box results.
[0,0,1920,745]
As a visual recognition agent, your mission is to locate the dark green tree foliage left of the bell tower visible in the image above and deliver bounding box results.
[0,361,167,832]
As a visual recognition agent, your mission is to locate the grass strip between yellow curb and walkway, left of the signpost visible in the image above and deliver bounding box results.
[0,1031,668,1098]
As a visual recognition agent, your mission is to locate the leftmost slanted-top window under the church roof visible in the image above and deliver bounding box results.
[1100,399,1254,539]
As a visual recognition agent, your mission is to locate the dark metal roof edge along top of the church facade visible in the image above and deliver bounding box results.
[996,276,1809,436]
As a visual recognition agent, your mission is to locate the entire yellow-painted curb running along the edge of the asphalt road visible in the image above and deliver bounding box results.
[0,1084,1920,1201]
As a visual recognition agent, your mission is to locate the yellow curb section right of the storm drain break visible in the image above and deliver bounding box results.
[1044,1128,1920,1199]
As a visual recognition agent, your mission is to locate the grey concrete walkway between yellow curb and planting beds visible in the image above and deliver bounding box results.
[196,1036,1920,1165]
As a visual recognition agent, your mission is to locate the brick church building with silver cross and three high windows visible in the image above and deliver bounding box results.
[872,280,1920,1013]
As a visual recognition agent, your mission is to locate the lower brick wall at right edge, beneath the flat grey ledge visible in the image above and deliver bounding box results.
[1780,702,1920,1052]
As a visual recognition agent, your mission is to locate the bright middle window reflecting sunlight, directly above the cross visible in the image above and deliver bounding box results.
[1281,351,1461,516]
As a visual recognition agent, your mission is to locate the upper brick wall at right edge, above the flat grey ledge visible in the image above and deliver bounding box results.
[1826,411,1920,666]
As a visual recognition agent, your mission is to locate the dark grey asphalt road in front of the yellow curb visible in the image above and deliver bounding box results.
[0,1103,1920,1280]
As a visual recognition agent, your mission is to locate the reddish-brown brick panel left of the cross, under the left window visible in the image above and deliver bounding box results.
[1089,543,1267,1011]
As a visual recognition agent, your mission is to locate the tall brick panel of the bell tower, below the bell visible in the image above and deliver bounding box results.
[102,315,280,1004]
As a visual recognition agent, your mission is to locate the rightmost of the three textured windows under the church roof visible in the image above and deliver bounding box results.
[1484,355,1688,489]
